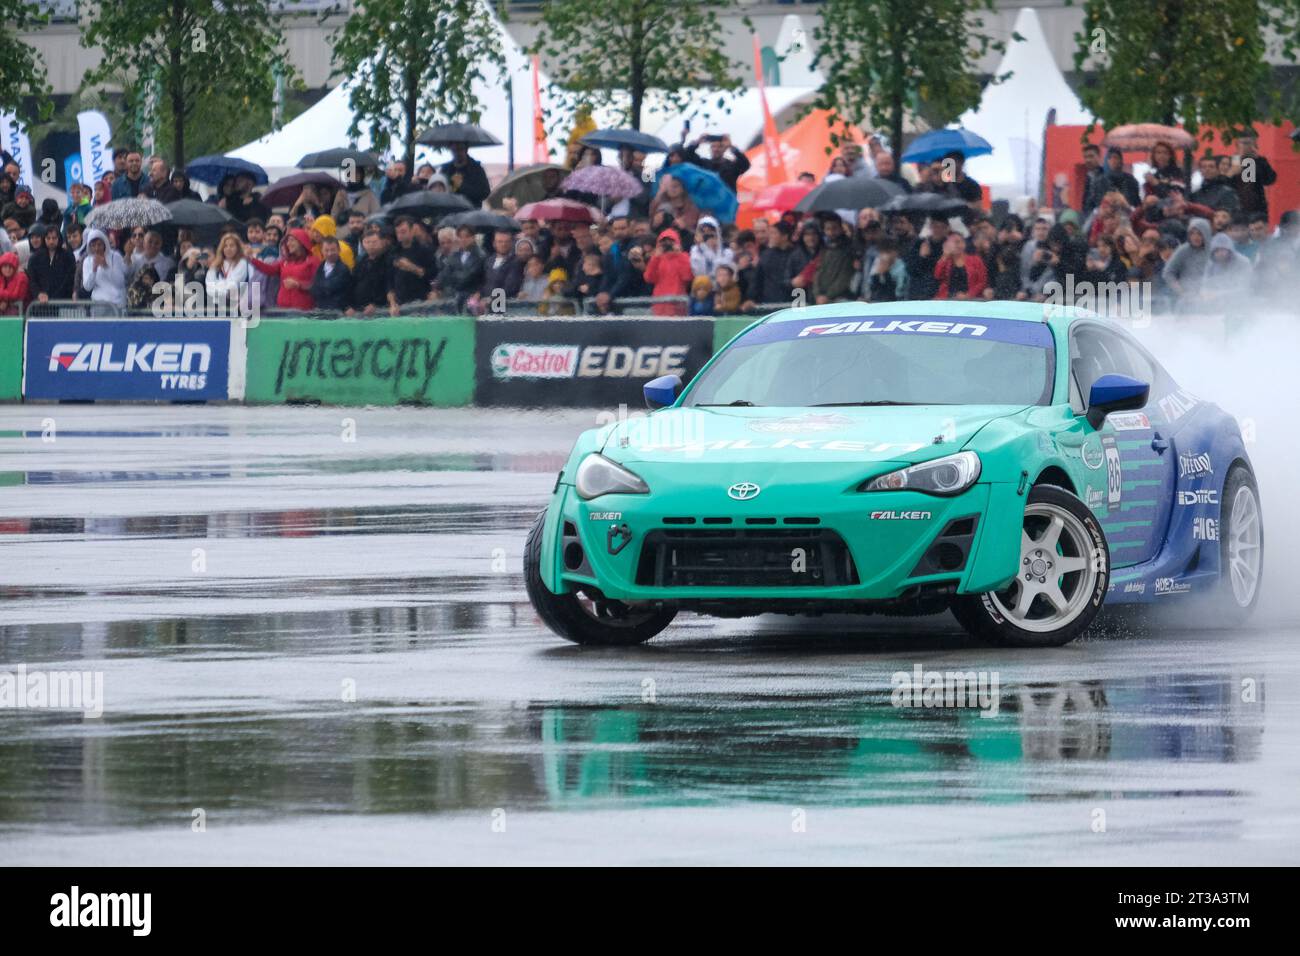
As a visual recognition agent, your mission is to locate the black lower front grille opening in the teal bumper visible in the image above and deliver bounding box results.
[637,528,858,588]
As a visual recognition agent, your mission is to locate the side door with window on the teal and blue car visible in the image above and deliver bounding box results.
[1070,323,1177,567]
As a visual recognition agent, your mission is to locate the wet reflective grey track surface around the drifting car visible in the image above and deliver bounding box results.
[0,406,1300,865]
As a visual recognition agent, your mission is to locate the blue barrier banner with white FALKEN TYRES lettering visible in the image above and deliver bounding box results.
[22,319,231,402]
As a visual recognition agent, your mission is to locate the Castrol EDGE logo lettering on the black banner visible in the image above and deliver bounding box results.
[491,343,690,378]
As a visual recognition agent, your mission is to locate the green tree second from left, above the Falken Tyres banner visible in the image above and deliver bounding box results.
[81,0,286,165]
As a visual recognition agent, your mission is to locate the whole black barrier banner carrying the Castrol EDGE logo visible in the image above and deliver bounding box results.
[475,319,714,408]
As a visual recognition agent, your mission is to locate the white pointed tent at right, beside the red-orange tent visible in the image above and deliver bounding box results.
[958,7,1092,199]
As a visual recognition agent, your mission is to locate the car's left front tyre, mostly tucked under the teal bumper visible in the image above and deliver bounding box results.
[524,511,677,648]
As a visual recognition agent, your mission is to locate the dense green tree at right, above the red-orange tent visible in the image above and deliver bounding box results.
[1074,0,1300,133]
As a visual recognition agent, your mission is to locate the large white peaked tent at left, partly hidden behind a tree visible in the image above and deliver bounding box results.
[230,6,546,179]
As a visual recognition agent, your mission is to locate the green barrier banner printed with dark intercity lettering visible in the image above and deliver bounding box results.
[244,316,475,406]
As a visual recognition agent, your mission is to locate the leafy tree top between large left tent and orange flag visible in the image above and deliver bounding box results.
[533,0,749,130]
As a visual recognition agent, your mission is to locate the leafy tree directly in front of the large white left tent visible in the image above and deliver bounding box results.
[332,0,504,169]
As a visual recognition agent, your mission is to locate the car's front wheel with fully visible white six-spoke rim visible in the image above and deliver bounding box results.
[952,485,1110,648]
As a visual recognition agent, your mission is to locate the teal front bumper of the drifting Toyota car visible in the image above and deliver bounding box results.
[542,483,1024,604]
